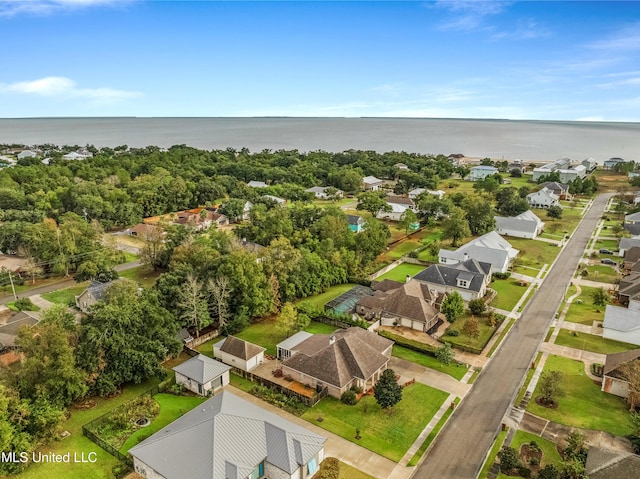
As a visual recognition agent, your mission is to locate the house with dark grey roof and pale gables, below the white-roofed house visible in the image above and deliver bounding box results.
[413,259,493,301]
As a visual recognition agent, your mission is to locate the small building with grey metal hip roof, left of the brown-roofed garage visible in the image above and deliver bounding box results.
[173,354,231,396]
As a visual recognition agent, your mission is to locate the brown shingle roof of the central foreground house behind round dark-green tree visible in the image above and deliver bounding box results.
[282,327,393,388]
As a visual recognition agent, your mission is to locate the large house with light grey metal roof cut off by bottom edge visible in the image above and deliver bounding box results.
[129,391,326,479]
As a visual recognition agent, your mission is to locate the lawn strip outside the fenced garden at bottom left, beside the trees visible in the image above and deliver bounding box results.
[14,379,159,479]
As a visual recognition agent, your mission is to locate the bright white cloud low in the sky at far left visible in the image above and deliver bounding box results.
[0,77,142,103]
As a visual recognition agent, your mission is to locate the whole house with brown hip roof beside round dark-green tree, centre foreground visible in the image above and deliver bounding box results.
[282,327,393,398]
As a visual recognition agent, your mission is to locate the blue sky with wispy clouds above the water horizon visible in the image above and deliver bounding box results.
[0,0,640,121]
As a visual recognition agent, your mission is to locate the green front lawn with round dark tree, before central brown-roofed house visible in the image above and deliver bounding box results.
[302,383,448,462]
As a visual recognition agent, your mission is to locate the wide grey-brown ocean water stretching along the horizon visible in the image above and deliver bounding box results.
[0,118,640,163]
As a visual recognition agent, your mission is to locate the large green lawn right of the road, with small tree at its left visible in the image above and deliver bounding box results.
[527,355,631,436]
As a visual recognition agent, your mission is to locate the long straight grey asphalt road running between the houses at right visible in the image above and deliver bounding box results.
[412,194,612,479]
